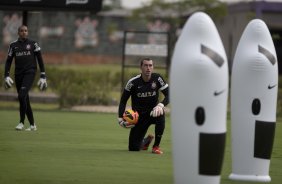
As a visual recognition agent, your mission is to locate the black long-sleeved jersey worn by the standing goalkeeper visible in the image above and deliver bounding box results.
[4,39,45,77]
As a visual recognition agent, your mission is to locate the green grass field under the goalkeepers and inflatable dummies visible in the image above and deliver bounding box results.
[0,108,282,184]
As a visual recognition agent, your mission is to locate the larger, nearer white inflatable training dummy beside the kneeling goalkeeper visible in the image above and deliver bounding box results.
[170,12,228,184]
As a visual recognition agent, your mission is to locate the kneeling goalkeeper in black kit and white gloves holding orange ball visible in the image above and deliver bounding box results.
[118,58,169,154]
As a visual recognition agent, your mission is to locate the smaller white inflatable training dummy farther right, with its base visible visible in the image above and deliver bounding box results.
[229,19,278,182]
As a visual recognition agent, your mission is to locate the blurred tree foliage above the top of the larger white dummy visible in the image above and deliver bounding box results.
[131,0,227,27]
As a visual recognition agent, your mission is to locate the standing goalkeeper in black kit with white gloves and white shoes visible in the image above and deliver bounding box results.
[4,25,47,131]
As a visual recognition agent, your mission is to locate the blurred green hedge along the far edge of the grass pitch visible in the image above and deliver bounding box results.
[0,66,282,115]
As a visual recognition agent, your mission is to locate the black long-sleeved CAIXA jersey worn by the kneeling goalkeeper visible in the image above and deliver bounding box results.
[119,73,169,117]
